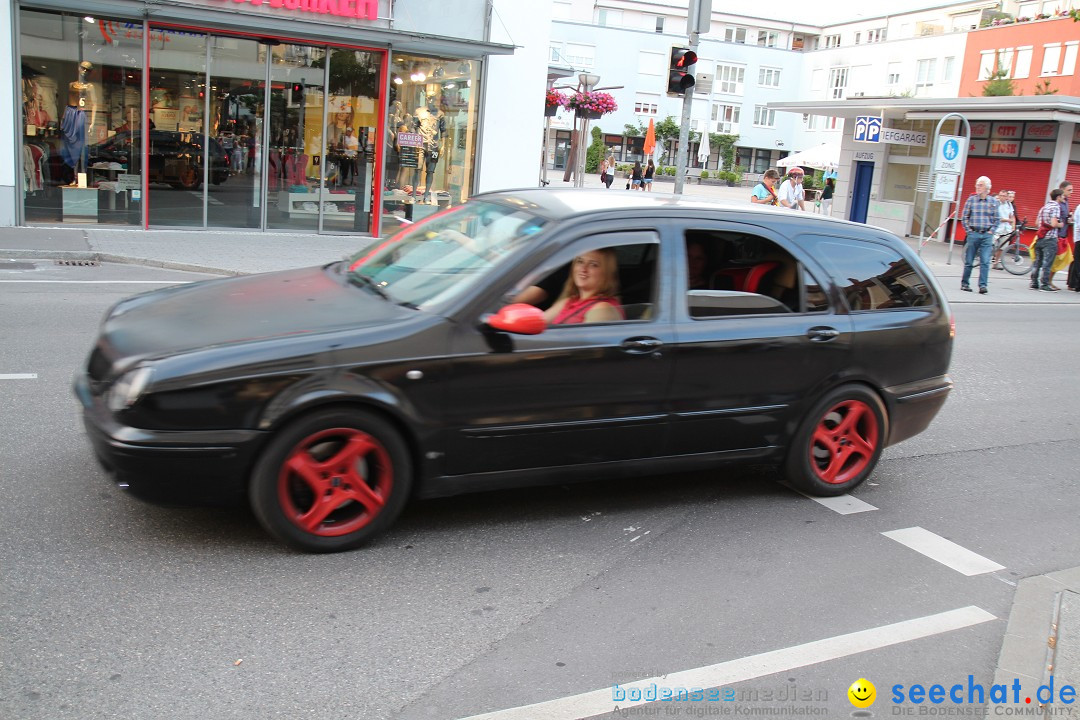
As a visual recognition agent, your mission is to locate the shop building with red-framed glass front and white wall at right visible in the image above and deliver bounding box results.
[0,0,550,234]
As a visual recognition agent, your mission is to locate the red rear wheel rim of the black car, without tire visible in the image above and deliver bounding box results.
[810,399,880,485]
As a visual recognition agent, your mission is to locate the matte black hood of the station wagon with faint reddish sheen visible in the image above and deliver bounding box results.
[100,266,417,362]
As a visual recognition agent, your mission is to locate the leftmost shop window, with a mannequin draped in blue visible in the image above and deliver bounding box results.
[19,10,143,225]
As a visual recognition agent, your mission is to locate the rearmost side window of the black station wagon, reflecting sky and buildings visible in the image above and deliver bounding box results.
[818,242,934,311]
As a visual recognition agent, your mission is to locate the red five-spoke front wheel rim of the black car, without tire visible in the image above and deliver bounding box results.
[278,427,394,538]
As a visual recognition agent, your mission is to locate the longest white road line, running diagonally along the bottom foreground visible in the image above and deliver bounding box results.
[462,606,997,720]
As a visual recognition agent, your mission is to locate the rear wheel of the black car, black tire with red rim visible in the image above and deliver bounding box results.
[784,385,889,495]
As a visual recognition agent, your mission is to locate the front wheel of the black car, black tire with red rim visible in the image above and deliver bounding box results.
[248,408,413,553]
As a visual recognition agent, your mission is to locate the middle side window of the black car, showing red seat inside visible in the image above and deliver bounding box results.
[685,230,828,320]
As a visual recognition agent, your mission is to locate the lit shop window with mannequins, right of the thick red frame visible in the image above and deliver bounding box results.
[382,55,480,233]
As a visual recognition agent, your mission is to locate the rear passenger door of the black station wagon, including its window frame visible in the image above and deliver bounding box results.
[671,220,852,456]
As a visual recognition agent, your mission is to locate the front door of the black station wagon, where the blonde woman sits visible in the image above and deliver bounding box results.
[445,223,674,475]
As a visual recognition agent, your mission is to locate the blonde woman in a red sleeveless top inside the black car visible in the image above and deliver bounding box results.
[544,247,625,325]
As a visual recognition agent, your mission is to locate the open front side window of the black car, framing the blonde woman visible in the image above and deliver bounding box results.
[511,237,660,325]
